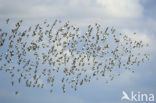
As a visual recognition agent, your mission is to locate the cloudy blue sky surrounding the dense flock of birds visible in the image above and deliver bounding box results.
[0,0,156,103]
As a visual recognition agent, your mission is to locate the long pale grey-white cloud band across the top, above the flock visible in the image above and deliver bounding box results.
[0,0,143,18]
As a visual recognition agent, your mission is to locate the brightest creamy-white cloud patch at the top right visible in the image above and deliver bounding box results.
[97,0,143,18]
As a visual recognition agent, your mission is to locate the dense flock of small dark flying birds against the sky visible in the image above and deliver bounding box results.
[0,19,149,95]
